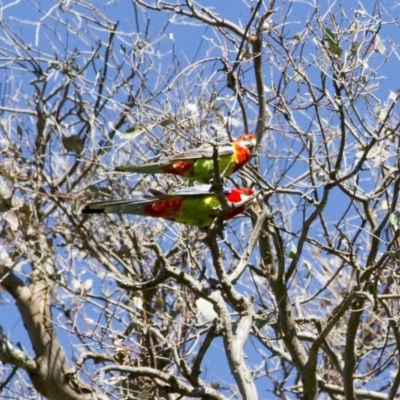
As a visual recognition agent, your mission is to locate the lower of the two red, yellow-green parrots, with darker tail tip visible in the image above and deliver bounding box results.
[82,185,254,227]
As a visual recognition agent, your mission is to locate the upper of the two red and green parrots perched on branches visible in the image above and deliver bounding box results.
[115,134,256,183]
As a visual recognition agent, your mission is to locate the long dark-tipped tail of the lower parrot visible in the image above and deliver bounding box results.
[82,199,154,215]
